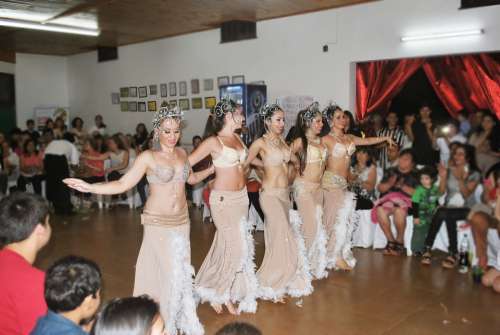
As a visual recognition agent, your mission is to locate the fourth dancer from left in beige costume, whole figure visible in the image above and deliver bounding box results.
[292,103,328,279]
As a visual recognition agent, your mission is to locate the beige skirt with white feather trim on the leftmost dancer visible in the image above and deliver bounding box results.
[134,207,204,335]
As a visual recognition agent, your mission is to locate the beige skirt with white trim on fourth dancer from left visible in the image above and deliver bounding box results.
[293,179,328,279]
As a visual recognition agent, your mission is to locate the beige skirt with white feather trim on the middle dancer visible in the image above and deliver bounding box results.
[257,188,313,300]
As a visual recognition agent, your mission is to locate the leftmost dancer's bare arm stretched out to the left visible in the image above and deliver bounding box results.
[63,150,148,194]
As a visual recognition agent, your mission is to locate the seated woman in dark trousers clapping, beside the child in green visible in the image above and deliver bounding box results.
[422,144,481,269]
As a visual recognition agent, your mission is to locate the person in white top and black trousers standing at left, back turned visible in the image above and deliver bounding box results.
[43,132,80,214]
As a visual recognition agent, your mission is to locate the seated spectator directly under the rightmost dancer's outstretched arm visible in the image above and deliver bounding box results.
[349,146,377,210]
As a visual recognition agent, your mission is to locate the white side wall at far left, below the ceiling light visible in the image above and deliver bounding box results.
[15,53,68,128]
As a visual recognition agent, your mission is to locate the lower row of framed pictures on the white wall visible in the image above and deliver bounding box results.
[120,97,217,112]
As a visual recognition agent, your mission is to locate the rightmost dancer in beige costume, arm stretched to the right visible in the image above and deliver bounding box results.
[321,105,393,270]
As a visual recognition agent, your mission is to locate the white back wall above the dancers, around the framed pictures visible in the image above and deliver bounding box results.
[16,0,500,142]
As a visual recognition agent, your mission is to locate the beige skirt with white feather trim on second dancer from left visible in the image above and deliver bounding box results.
[195,188,258,313]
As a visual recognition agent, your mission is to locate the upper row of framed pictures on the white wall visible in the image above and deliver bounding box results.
[112,75,245,104]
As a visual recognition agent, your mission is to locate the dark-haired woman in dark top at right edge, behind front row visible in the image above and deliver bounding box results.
[469,112,500,174]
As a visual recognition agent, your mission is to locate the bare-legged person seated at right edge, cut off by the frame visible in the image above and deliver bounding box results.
[469,166,500,270]
